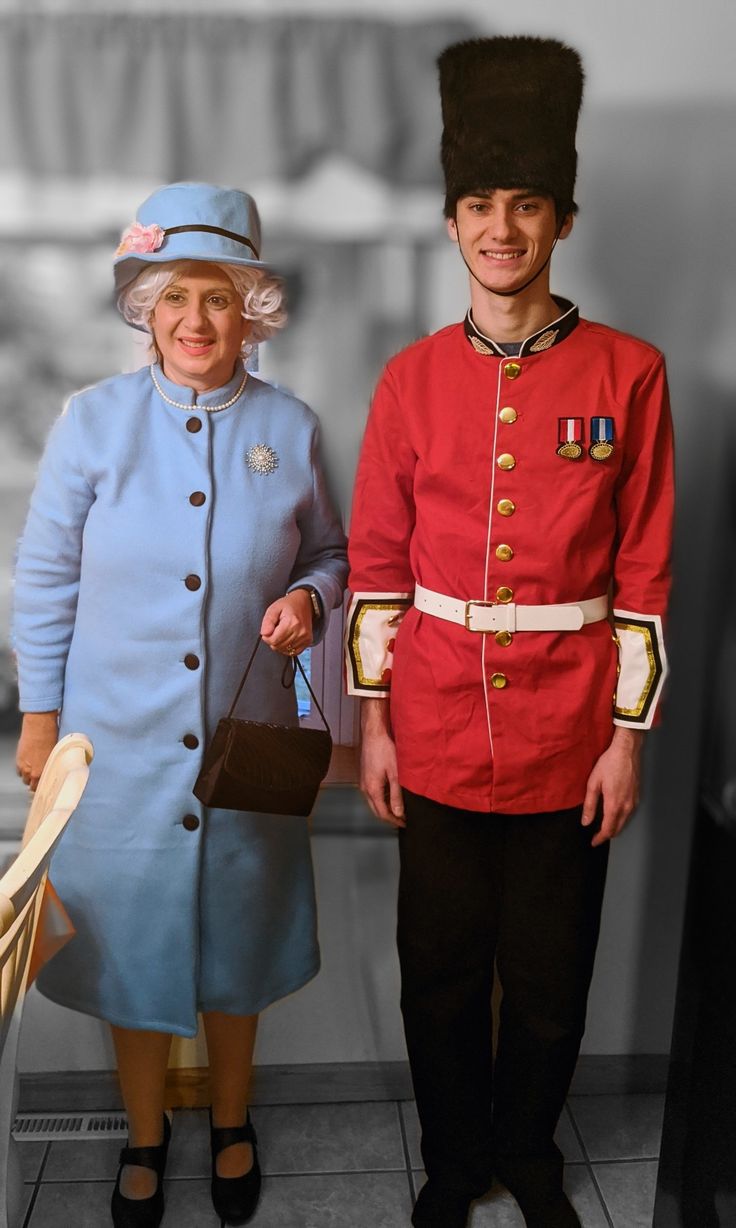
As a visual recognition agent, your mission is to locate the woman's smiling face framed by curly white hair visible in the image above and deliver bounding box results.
[151,260,251,392]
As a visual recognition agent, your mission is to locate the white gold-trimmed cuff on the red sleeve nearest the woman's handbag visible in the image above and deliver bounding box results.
[345,593,413,699]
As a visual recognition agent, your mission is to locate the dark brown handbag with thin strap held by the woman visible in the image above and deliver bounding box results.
[193,636,332,815]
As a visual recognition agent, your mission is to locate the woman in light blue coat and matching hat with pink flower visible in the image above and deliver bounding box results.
[15,184,346,1228]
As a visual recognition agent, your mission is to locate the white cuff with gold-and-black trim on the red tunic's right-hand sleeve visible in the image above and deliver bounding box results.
[613,609,667,729]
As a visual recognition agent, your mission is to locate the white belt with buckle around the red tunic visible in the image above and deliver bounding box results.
[414,585,608,634]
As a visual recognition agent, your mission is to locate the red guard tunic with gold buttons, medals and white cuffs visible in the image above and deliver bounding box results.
[346,308,672,813]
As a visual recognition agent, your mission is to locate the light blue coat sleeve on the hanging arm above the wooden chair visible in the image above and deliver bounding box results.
[12,399,95,712]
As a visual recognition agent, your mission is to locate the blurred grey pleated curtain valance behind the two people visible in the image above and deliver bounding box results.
[0,12,473,185]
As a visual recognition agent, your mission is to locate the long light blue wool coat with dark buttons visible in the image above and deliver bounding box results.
[14,367,346,1035]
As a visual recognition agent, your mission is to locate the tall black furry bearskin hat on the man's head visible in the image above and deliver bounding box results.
[437,36,584,217]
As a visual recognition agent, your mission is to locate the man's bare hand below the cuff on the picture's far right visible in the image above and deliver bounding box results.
[581,726,644,847]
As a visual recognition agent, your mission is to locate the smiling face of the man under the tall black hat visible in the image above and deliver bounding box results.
[447,188,573,292]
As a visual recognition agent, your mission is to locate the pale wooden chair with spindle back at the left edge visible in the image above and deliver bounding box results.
[0,733,92,1228]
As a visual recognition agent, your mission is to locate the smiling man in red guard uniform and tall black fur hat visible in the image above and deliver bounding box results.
[348,38,672,1228]
